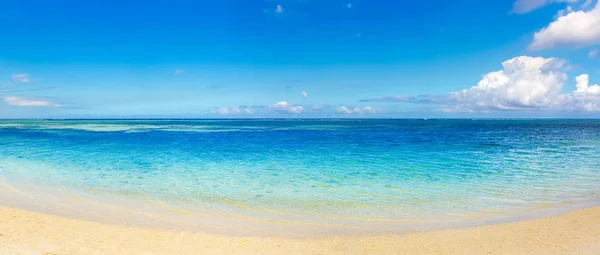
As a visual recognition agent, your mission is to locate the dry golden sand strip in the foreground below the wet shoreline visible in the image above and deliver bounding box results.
[0,207,600,255]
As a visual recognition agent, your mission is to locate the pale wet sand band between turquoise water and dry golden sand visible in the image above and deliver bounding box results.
[0,179,600,238]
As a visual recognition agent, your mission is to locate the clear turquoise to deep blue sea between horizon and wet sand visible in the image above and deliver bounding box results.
[0,120,600,232]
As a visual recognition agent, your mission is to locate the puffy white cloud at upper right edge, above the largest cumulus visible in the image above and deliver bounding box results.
[529,2,600,49]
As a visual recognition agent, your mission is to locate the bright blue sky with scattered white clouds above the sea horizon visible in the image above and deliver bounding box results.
[0,0,600,118]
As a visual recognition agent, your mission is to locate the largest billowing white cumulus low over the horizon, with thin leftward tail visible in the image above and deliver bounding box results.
[362,56,600,111]
